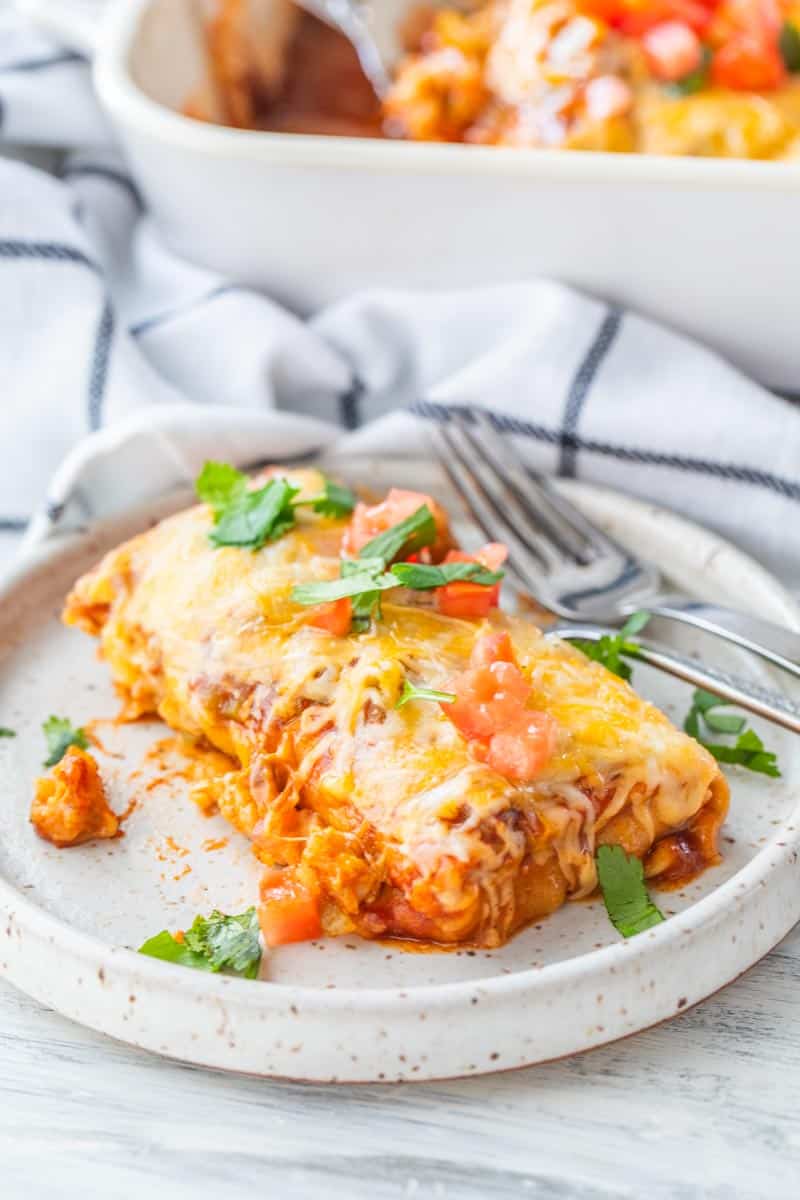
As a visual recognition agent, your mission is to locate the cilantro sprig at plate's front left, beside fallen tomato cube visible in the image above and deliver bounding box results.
[139,908,261,979]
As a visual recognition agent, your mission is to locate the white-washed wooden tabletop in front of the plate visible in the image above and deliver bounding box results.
[0,930,800,1200]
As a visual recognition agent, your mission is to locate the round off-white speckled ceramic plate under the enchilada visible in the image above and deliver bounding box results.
[0,460,800,1080]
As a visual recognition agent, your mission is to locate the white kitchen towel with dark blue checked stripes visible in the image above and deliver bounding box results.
[0,5,800,583]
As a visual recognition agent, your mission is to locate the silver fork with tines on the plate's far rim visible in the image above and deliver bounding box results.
[429,409,800,690]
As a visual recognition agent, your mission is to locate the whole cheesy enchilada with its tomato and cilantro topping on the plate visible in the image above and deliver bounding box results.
[56,463,734,955]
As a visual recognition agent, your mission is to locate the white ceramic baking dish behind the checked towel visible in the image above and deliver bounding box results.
[23,0,800,386]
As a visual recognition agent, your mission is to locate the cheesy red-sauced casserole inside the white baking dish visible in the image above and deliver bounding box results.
[196,0,800,158]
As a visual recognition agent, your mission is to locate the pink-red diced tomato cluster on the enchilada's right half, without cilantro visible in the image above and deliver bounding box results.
[441,634,558,781]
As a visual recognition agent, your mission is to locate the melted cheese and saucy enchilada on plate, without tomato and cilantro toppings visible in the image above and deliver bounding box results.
[66,476,724,943]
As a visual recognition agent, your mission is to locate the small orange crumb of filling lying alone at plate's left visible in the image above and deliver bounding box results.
[30,745,120,848]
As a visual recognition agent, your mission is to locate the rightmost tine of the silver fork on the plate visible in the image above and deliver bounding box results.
[471,408,613,562]
